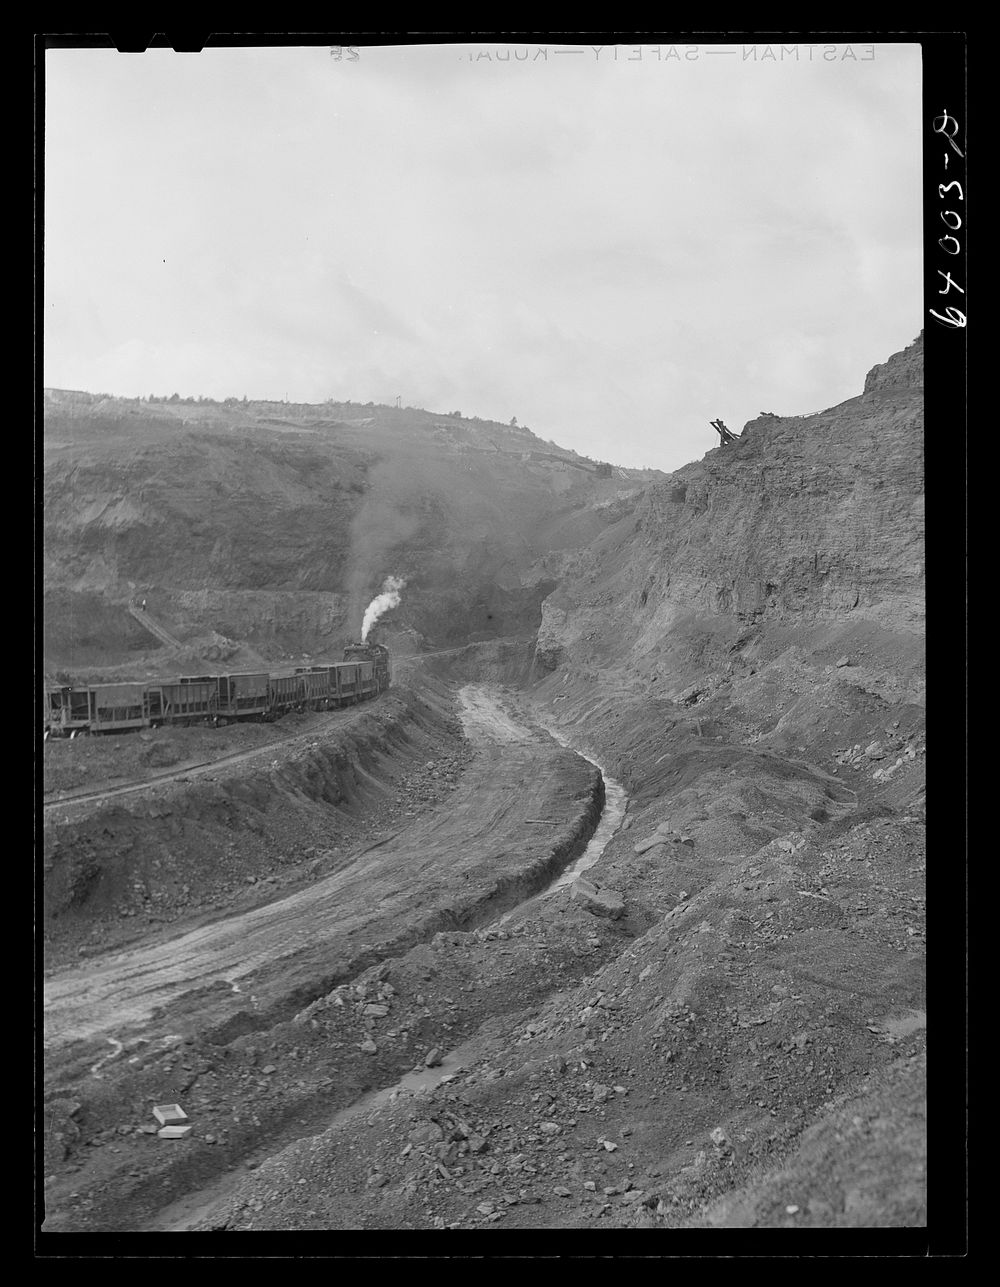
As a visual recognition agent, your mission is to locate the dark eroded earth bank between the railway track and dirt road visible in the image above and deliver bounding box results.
[44,681,461,947]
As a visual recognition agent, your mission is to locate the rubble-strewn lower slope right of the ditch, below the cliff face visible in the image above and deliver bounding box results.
[162,653,927,1232]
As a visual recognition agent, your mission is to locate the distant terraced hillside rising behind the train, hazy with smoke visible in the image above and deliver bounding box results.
[44,390,664,665]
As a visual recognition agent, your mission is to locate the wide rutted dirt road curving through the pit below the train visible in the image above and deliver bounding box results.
[44,686,601,1058]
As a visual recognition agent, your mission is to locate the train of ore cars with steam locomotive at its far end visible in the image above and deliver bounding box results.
[45,644,390,737]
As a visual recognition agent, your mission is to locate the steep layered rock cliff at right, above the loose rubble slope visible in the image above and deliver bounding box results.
[539,336,923,681]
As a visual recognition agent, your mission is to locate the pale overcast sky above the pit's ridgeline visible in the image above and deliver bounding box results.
[44,44,921,470]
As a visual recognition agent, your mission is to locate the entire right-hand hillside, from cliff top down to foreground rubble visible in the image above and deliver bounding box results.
[136,344,927,1232]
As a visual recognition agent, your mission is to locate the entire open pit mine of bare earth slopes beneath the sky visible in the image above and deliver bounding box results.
[39,337,927,1240]
